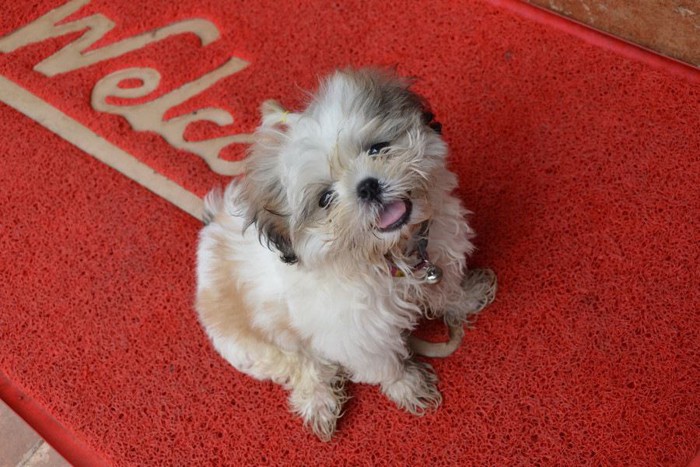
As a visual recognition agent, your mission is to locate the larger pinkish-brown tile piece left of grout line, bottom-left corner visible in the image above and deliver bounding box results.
[0,401,41,467]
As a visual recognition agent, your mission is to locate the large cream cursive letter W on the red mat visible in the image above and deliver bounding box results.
[0,0,219,76]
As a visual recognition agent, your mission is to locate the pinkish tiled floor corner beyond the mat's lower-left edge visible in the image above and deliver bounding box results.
[0,401,70,467]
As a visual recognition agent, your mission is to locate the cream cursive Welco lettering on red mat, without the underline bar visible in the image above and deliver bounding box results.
[0,0,251,175]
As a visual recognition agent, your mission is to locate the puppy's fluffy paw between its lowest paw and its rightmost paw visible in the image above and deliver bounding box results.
[382,361,442,415]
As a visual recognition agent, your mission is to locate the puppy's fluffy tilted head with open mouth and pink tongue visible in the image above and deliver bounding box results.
[242,70,447,266]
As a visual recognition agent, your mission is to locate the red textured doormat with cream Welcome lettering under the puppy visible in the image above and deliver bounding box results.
[0,0,700,465]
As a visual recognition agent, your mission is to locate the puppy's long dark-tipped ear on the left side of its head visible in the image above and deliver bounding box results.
[241,101,298,264]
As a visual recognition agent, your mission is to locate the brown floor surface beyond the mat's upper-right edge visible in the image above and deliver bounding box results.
[527,0,700,66]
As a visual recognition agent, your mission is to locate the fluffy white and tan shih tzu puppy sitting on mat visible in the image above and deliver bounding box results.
[196,69,496,440]
